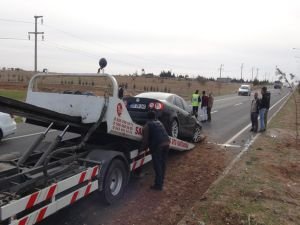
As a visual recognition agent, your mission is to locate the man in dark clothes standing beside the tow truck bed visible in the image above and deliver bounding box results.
[139,111,170,191]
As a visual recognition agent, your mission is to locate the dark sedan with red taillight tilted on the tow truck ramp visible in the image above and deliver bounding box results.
[123,92,201,141]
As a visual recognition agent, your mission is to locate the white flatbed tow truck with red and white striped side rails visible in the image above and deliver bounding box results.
[0,60,200,225]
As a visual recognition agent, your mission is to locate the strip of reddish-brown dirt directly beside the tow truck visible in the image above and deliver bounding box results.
[106,143,231,225]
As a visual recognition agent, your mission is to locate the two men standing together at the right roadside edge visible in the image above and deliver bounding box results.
[250,87,271,132]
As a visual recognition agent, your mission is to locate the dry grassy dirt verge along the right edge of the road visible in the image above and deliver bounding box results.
[178,90,300,225]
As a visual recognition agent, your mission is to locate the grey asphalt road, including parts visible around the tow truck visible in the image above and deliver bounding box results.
[0,86,289,225]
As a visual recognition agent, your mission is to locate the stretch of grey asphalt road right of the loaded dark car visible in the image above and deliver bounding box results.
[202,89,289,147]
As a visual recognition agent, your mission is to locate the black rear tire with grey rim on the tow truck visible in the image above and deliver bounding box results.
[102,159,129,205]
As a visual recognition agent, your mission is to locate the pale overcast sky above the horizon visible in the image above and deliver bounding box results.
[0,0,300,79]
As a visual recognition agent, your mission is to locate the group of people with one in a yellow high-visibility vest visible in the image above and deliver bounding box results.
[192,90,214,122]
